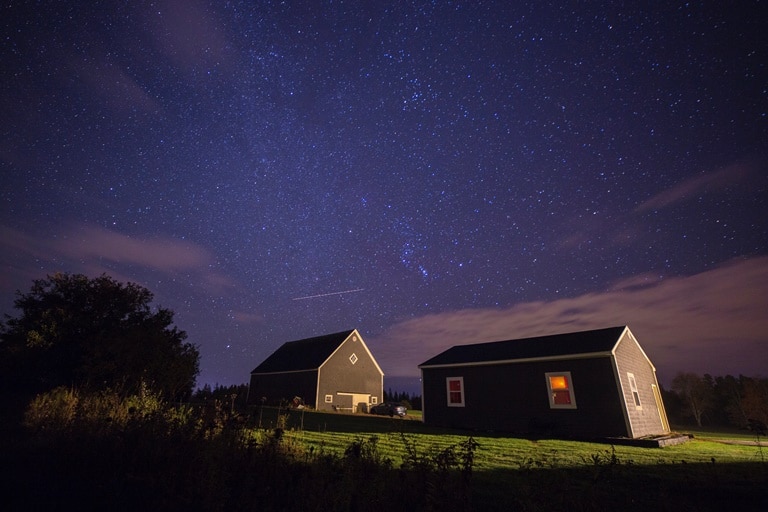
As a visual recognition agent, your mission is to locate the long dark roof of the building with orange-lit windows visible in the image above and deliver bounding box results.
[419,326,626,368]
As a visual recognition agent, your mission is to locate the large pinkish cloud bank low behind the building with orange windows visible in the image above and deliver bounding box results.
[369,257,768,380]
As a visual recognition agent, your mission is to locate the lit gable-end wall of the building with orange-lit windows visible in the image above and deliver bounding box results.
[614,330,668,438]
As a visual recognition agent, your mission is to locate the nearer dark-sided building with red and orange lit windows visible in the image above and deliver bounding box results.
[419,326,669,439]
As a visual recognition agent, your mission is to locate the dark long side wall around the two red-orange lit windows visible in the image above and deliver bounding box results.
[422,356,628,437]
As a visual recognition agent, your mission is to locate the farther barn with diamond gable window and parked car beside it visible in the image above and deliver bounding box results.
[248,329,384,412]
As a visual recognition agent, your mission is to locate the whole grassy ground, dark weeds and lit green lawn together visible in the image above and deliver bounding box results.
[6,389,768,512]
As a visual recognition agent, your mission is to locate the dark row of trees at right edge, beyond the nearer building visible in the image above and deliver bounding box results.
[664,373,768,429]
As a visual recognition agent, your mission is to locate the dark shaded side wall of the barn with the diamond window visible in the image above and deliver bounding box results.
[248,370,317,407]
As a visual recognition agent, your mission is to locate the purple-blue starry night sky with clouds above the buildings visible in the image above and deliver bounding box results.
[0,0,768,387]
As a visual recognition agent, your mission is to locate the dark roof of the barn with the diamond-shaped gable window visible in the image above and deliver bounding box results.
[251,330,354,373]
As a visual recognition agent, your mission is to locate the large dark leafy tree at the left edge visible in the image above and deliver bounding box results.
[0,274,200,399]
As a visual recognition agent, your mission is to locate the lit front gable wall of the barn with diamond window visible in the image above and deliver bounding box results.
[317,333,384,410]
